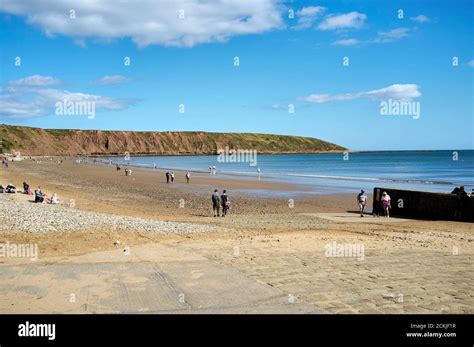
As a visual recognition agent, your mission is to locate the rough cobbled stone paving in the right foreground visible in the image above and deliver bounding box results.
[176,235,474,313]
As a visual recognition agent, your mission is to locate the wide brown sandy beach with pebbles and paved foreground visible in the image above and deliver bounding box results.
[0,158,474,313]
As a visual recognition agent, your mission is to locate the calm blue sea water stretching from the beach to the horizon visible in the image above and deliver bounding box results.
[102,150,474,194]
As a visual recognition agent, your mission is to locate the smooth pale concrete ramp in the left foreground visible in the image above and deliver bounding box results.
[0,244,324,313]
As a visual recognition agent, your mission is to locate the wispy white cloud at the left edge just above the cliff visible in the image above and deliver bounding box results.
[0,75,135,118]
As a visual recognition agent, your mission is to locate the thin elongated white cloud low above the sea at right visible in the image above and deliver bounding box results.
[301,84,421,104]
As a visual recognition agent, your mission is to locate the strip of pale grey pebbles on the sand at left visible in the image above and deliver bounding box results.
[0,194,218,234]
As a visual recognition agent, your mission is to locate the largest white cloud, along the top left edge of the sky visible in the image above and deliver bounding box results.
[0,0,283,47]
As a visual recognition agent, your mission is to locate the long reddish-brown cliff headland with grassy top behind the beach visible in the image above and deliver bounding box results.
[0,125,345,155]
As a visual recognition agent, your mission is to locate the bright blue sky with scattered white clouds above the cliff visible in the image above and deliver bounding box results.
[0,0,474,150]
